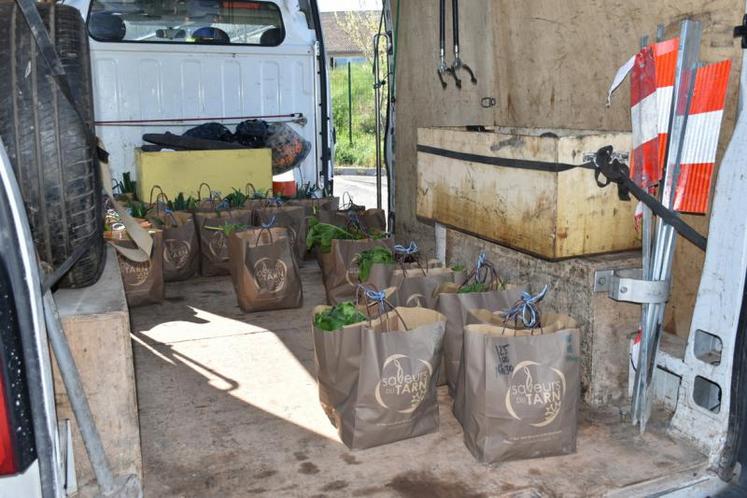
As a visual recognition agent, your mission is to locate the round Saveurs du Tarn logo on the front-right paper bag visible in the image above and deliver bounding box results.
[506,361,566,427]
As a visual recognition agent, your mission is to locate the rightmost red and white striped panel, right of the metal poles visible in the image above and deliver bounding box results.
[674,60,731,214]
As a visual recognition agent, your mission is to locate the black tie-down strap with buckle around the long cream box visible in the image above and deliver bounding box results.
[417,145,707,251]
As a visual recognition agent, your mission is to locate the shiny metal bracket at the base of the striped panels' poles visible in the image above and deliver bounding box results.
[594,268,669,304]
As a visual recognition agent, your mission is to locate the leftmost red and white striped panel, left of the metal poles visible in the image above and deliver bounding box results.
[630,47,659,188]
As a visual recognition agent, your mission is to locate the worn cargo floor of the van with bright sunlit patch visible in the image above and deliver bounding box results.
[132,262,704,498]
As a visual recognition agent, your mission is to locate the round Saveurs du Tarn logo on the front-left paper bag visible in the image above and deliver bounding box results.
[374,354,433,413]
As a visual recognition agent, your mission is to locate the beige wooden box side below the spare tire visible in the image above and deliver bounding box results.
[53,247,143,498]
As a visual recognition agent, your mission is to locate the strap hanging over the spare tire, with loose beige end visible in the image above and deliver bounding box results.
[16,0,153,290]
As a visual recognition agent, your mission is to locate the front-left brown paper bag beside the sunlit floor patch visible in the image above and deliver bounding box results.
[334,308,446,449]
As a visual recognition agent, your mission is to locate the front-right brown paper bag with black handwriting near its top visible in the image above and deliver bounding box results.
[462,316,581,463]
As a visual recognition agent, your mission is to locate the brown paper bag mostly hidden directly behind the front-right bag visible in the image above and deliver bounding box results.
[436,283,521,398]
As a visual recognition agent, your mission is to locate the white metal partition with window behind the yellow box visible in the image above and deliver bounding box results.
[61,0,332,189]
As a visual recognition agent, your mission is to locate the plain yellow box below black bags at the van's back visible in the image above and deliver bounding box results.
[135,148,272,202]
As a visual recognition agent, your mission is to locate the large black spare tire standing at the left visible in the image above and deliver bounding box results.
[0,0,104,287]
